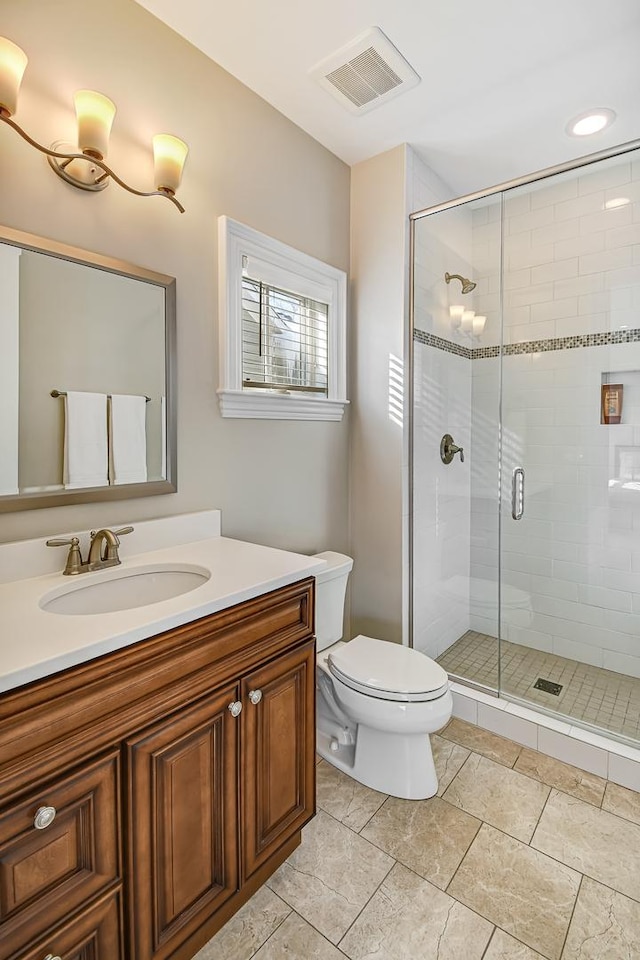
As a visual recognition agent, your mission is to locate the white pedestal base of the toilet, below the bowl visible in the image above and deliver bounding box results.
[317,724,438,800]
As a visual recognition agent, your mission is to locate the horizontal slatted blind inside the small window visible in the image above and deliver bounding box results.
[242,276,329,397]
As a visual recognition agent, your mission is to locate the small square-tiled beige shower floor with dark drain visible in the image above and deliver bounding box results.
[438,630,640,740]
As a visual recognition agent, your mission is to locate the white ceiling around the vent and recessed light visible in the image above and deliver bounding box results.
[138,0,640,195]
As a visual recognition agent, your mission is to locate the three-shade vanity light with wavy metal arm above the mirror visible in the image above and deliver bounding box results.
[0,37,189,213]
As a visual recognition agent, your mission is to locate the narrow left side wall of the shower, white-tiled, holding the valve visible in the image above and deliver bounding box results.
[413,197,472,657]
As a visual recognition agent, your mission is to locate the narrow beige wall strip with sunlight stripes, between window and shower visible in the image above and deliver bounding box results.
[350,146,407,642]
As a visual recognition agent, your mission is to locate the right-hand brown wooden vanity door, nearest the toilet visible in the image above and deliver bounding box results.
[241,641,315,881]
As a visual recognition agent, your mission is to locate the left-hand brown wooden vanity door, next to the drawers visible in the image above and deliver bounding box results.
[126,686,240,960]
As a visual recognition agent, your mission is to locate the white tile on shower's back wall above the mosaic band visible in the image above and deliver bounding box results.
[472,155,640,345]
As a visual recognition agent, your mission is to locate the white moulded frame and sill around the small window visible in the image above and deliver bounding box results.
[218,216,349,420]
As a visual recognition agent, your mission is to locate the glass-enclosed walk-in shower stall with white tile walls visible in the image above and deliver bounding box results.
[409,142,640,746]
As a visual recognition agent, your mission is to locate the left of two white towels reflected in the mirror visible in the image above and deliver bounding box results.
[62,392,109,490]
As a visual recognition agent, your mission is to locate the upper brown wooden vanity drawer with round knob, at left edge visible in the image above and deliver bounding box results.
[0,752,120,960]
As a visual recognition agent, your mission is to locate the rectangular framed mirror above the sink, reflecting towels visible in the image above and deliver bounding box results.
[0,227,177,512]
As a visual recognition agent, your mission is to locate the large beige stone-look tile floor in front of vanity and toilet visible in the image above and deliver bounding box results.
[195,719,640,960]
